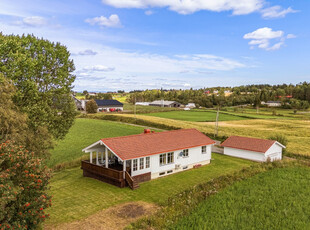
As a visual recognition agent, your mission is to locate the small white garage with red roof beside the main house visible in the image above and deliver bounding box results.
[221,136,285,162]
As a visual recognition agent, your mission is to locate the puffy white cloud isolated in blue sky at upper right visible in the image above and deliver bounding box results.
[243,27,296,50]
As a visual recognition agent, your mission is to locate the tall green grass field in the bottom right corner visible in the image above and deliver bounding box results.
[171,167,310,230]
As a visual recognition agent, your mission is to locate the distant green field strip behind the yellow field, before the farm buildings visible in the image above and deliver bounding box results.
[145,110,249,122]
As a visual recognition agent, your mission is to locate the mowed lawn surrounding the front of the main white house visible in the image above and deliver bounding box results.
[47,154,253,226]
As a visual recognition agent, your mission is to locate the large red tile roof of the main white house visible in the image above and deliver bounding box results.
[101,129,215,160]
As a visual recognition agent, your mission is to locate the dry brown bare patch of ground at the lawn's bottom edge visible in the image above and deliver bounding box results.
[44,201,158,230]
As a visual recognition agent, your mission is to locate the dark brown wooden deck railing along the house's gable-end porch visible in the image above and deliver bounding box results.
[82,160,123,180]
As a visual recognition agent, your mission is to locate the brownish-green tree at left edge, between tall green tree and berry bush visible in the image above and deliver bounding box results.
[0,74,53,158]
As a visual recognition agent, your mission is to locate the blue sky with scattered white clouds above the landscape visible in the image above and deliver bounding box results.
[0,0,310,92]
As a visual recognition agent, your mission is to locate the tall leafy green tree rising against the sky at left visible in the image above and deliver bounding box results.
[0,34,75,139]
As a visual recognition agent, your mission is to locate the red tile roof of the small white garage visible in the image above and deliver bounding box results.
[221,136,276,153]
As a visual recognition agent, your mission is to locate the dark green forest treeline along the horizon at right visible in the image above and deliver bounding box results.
[127,82,310,109]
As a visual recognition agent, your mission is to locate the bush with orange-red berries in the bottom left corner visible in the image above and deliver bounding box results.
[0,141,51,229]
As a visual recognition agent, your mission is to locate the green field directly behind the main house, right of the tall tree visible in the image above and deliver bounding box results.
[48,118,147,167]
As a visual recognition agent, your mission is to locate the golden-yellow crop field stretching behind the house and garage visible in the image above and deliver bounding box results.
[106,114,310,156]
